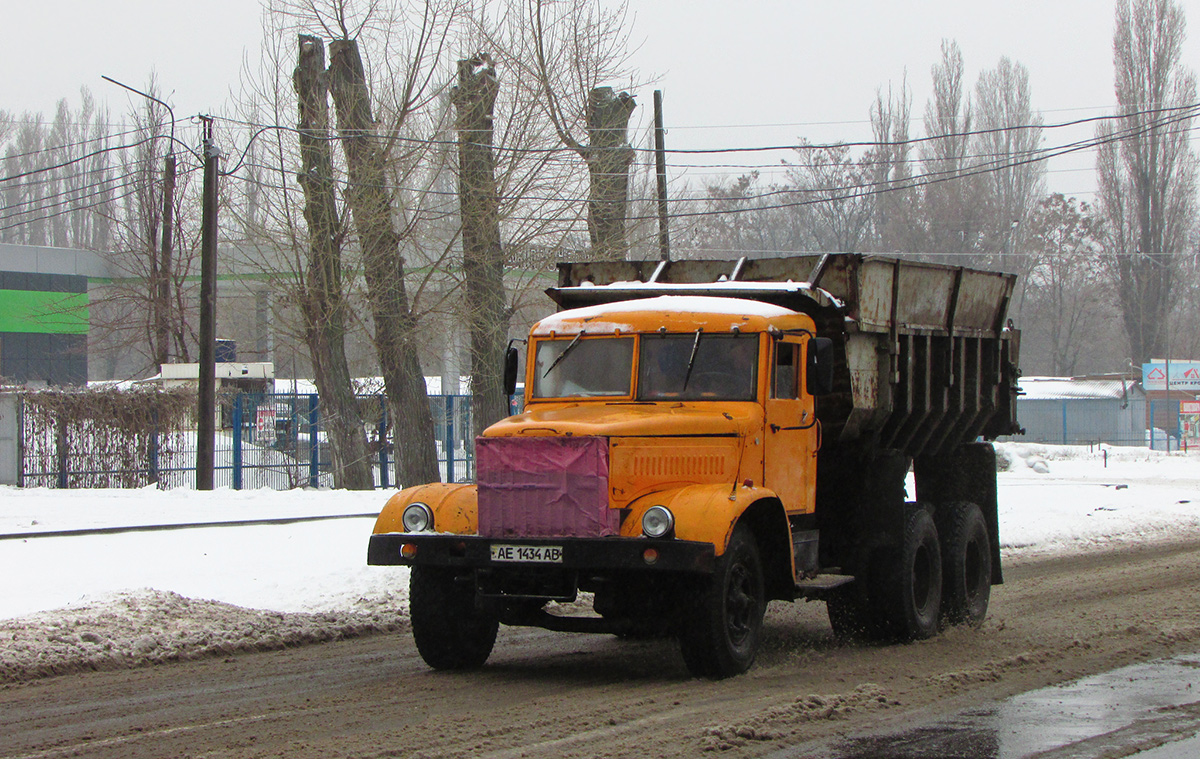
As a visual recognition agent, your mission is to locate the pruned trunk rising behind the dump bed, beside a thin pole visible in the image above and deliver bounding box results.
[583,86,637,259]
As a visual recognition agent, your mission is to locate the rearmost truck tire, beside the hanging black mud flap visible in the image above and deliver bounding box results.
[942,502,991,627]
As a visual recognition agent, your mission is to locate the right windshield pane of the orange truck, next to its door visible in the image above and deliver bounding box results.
[637,333,758,401]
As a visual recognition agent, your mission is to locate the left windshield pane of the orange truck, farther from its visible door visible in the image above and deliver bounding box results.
[533,336,634,398]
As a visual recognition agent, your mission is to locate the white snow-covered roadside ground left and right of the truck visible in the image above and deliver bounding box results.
[0,443,1200,682]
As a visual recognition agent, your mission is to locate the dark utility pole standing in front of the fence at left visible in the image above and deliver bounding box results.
[196,116,221,490]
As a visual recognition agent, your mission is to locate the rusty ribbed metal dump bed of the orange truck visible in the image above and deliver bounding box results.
[547,253,1020,456]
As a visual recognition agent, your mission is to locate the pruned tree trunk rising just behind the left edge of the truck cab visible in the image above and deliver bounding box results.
[451,54,509,436]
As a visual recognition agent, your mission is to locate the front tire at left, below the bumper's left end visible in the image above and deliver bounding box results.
[408,567,499,669]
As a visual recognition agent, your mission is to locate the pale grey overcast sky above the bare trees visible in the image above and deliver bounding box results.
[7,0,1200,196]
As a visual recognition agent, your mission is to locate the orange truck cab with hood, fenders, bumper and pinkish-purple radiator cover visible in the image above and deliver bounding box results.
[371,295,828,675]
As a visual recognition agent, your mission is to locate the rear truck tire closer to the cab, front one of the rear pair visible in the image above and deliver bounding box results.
[888,509,942,640]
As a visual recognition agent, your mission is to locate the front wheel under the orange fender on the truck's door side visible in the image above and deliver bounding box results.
[679,526,767,680]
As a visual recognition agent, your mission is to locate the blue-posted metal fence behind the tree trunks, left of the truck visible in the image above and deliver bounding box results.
[18,393,475,490]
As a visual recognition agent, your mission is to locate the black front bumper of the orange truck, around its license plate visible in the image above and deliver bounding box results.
[367,532,716,574]
